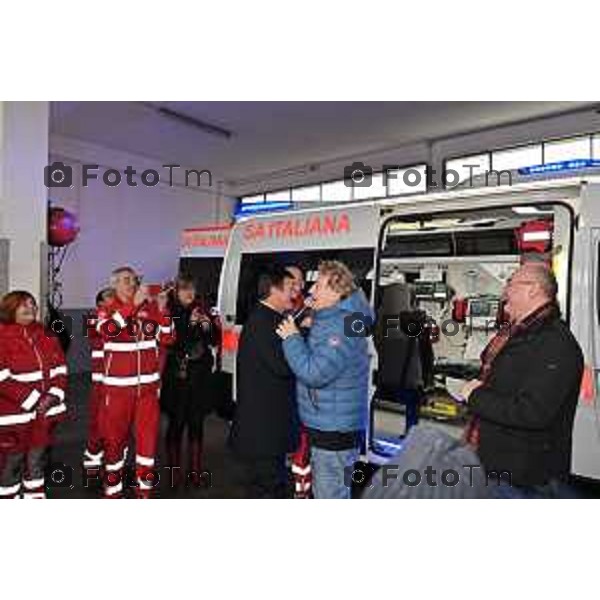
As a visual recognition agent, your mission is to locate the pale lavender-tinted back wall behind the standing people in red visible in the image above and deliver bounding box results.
[48,137,233,372]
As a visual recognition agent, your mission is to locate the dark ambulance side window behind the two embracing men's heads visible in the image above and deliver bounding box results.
[236,248,374,325]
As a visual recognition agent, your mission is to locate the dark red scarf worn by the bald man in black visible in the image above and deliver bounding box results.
[463,302,560,450]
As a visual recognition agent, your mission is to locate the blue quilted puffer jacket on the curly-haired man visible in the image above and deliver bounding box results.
[283,290,372,432]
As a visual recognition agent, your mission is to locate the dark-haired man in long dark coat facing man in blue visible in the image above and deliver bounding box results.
[232,267,298,498]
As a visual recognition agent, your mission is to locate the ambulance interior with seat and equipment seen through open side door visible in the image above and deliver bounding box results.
[369,204,572,455]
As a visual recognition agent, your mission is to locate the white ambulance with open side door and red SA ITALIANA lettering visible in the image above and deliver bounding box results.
[218,165,600,479]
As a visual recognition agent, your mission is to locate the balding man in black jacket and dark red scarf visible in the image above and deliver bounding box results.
[463,262,583,497]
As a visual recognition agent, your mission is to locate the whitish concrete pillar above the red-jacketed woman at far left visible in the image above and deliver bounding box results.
[0,102,49,304]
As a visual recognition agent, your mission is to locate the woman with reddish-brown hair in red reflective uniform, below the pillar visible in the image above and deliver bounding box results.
[0,291,67,498]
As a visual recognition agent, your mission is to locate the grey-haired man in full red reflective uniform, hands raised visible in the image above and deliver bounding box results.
[96,267,173,498]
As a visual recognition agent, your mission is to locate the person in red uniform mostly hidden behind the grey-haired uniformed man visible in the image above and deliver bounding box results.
[83,288,114,478]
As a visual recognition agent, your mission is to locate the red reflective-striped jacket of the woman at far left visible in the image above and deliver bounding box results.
[0,323,67,452]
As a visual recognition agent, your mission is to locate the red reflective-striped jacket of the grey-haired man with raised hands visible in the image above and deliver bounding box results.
[96,298,174,389]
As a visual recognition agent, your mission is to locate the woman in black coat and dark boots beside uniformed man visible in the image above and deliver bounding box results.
[161,277,216,479]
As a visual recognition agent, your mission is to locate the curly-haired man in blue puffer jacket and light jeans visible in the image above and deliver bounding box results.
[277,261,372,498]
